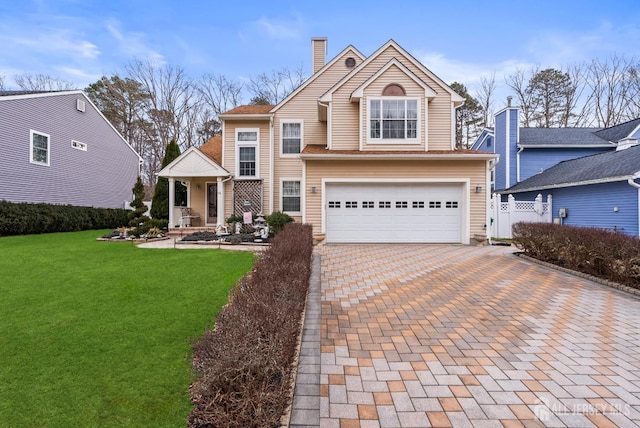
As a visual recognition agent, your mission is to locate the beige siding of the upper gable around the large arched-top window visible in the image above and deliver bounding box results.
[331,46,453,150]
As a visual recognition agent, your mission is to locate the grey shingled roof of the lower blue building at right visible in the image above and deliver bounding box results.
[500,146,640,194]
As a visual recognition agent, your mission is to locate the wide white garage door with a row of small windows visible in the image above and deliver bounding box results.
[326,183,462,243]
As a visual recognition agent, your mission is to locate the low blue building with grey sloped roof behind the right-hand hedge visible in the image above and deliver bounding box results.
[501,145,640,236]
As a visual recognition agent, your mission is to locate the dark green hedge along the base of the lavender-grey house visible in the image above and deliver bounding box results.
[0,201,129,236]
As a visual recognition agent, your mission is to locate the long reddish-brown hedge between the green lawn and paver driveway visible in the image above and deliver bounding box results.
[188,223,313,428]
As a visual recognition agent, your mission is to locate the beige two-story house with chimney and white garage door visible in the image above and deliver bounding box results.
[161,38,496,244]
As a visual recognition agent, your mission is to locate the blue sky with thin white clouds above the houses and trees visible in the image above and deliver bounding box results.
[0,0,640,103]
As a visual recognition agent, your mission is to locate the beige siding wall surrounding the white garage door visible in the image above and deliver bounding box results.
[305,160,487,238]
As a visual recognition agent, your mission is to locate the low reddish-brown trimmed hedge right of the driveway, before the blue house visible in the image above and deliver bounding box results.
[512,223,640,288]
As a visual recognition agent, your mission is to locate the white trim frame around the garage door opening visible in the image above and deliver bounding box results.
[320,177,470,244]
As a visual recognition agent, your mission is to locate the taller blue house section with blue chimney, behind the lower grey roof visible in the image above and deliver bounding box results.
[471,101,640,193]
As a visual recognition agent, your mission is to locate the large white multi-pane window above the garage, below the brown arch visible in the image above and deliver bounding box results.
[368,97,419,143]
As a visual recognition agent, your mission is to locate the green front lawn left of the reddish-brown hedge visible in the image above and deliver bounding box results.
[0,231,253,427]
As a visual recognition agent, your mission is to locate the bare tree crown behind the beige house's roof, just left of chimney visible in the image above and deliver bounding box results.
[249,67,305,104]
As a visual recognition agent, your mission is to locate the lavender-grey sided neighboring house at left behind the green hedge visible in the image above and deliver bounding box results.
[0,91,140,208]
